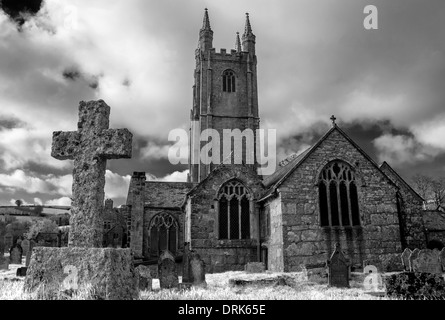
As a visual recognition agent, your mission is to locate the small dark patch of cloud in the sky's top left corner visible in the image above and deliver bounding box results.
[0,0,43,26]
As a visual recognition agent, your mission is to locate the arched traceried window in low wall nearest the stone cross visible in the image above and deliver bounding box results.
[148,212,179,257]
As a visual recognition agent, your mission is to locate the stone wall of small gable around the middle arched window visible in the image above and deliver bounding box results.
[190,165,263,273]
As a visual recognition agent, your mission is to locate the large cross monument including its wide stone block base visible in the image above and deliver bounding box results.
[24,100,138,300]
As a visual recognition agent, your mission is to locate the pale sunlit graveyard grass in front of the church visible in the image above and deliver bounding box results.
[0,271,388,300]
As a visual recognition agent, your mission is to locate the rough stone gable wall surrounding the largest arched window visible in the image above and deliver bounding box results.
[269,130,401,271]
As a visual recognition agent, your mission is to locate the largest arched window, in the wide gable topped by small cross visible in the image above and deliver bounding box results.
[318,160,360,227]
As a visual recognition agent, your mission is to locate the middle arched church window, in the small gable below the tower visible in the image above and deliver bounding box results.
[218,180,250,239]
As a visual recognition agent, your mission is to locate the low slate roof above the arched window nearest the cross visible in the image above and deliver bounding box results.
[145,181,196,208]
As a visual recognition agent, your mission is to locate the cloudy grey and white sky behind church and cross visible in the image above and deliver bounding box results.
[0,0,445,205]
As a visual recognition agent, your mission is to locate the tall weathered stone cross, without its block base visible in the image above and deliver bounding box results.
[51,100,133,248]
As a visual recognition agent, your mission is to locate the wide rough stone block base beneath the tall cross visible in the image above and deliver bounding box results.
[24,247,138,300]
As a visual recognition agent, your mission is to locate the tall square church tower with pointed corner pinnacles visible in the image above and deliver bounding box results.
[189,9,260,182]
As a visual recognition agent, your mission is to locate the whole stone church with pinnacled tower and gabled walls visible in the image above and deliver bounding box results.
[122,10,426,272]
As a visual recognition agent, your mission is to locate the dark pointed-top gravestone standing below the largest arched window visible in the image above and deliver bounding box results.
[327,243,349,288]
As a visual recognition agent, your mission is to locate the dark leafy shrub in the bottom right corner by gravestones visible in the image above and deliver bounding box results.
[385,272,445,300]
